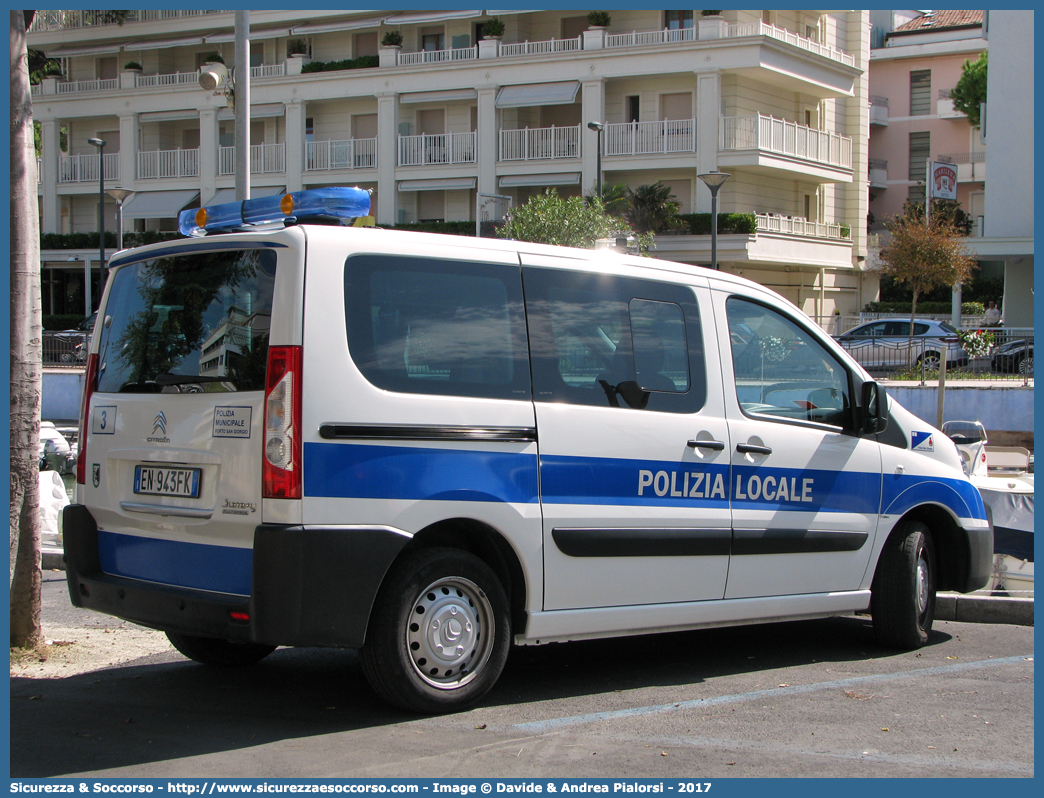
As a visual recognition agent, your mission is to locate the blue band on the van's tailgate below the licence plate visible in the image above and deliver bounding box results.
[98,530,254,595]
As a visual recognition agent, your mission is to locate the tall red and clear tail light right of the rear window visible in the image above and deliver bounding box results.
[261,347,301,498]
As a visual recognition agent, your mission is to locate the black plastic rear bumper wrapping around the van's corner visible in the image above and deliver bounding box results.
[62,504,409,648]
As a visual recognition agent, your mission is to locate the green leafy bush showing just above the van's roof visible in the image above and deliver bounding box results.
[497,188,653,252]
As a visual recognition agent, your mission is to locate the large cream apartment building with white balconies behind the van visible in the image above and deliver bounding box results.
[29,9,878,319]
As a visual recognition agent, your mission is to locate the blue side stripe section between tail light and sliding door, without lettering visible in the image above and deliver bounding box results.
[304,443,537,504]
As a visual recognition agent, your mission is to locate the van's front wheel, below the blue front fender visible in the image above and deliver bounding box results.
[870,521,935,649]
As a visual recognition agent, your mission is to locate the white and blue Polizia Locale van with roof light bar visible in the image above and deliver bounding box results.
[64,188,993,711]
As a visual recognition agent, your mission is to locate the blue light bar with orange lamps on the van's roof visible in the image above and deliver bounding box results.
[177,187,370,236]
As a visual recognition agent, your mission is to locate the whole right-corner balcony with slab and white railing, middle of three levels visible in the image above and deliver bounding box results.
[719,114,852,181]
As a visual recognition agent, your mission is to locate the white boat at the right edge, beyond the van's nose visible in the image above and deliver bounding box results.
[943,421,1034,596]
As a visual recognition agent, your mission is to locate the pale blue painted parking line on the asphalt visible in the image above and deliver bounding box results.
[512,654,1034,734]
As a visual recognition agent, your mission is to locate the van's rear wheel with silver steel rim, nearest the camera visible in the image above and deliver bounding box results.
[361,548,511,712]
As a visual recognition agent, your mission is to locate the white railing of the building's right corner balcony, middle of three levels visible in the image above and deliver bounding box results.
[719,114,852,169]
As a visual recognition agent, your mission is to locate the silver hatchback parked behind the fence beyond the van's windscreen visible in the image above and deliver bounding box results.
[834,319,968,369]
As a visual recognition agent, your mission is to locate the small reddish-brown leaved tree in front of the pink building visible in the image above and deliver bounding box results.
[881,213,975,363]
